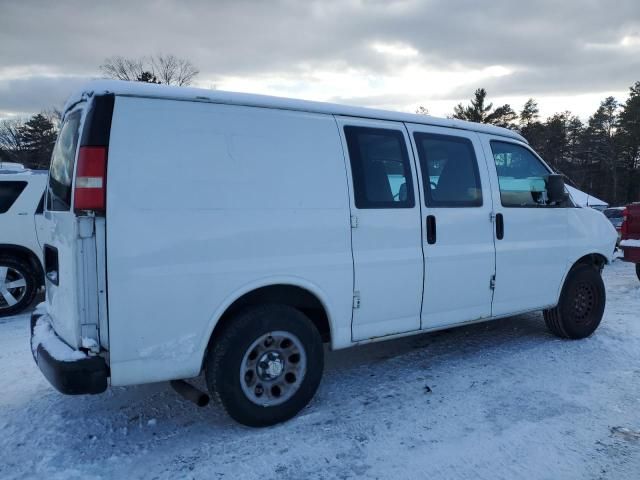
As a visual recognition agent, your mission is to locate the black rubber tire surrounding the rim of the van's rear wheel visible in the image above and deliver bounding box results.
[205,305,324,427]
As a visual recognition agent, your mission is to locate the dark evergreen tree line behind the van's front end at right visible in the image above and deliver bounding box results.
[436,85,640,205]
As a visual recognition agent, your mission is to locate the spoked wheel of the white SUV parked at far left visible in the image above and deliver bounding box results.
[0,256,38,317]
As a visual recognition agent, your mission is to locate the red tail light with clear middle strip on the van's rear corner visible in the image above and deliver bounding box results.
[73,147,107,212]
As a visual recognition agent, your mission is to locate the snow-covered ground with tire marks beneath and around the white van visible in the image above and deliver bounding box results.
[0,261,640,480]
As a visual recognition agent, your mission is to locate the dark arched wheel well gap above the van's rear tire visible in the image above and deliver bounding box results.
[211,285,331,342]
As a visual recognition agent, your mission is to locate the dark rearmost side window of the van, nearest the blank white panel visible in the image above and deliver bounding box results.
[344,127,415,208]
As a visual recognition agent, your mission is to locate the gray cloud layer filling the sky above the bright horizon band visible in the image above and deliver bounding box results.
[0,0,640,116]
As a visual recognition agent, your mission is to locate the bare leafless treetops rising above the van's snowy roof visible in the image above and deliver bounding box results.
[100,54,200,86]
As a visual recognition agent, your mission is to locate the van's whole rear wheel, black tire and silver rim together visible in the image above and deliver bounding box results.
[205,305,324,427]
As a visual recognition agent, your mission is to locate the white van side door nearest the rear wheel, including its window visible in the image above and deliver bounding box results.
[336,117,424,341]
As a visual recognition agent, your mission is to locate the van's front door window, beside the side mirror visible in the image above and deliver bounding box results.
[491,140,551,207]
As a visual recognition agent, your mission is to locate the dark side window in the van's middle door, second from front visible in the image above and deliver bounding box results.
[414,132,482,207]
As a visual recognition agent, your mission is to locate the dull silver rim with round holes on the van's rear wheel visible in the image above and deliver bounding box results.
[240,331,307,407]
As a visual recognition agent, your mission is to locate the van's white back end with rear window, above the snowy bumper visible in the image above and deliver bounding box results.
[44,96,113,350]
